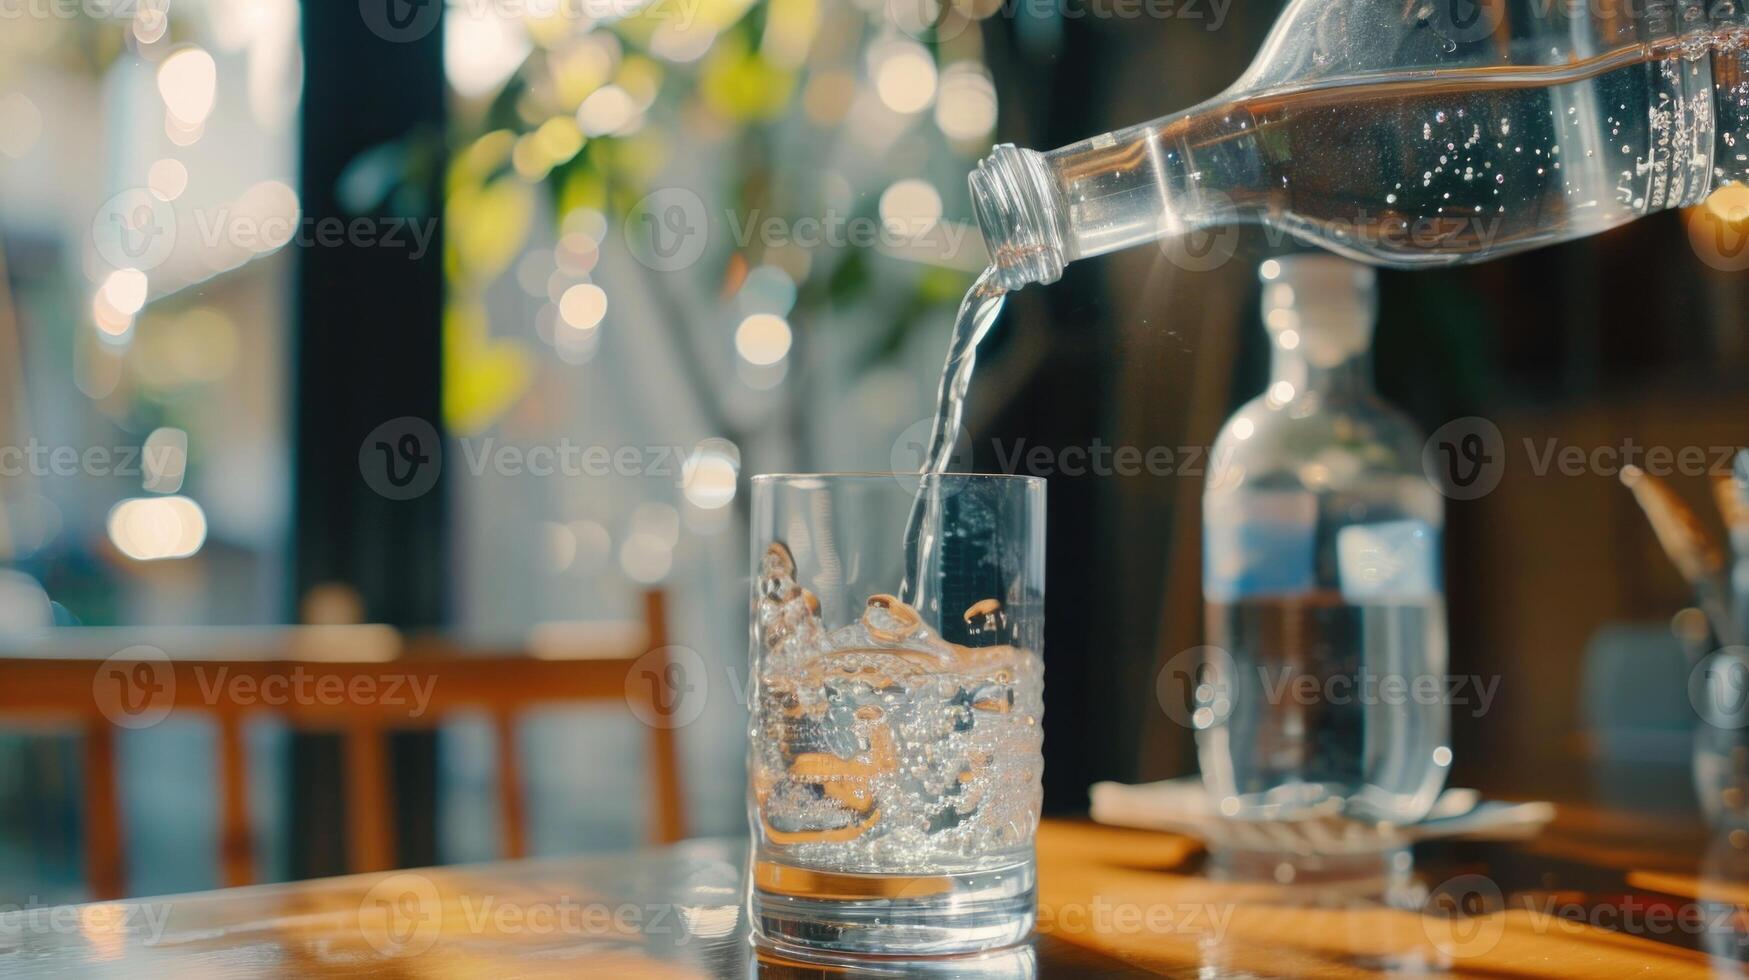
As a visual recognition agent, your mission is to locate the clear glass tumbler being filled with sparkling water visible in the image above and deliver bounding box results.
[747,474,1044,956]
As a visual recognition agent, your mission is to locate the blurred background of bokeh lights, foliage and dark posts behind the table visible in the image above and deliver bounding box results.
[0,0,1749,901]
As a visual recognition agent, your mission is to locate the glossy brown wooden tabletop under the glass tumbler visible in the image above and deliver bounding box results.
[0,807,1749,980]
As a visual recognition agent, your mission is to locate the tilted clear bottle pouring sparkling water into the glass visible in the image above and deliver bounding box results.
[971,0,1749,289]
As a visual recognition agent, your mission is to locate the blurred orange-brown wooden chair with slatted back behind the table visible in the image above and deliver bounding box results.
[0,592,686,900]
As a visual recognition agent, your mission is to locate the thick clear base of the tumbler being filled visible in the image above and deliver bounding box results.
[749,858,1037,959]
